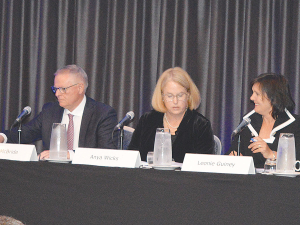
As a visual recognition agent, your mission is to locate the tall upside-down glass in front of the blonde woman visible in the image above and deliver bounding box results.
[153,128,172,166]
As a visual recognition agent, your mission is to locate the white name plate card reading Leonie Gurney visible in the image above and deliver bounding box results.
[181,153,255,174]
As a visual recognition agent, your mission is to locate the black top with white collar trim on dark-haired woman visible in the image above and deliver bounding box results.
[226,110,300,168]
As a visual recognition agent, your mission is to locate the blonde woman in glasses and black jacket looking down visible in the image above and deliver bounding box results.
[128,67,214,162]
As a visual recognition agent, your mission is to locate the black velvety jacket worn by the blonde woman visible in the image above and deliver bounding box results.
[127,109,214,162]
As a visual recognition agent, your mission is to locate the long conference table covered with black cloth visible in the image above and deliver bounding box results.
[0,160,300,225]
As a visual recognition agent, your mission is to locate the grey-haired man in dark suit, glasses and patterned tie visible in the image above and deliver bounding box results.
[0,65,117,159]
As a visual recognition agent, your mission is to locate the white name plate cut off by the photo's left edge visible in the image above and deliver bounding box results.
[0,144,38,161]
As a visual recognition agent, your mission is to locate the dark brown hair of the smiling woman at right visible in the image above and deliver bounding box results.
[251,73,295,119]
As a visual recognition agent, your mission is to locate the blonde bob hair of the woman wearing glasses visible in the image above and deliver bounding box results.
[152,67,201,113]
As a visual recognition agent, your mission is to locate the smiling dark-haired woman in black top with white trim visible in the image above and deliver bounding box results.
[228,73,300,168]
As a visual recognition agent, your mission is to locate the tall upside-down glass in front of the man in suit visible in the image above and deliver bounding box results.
[49,123,68,160]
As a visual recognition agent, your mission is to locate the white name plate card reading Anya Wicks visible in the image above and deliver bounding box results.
[72,148,141,168]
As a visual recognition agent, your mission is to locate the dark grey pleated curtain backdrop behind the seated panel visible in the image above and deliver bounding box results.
[0,0,300,151]
